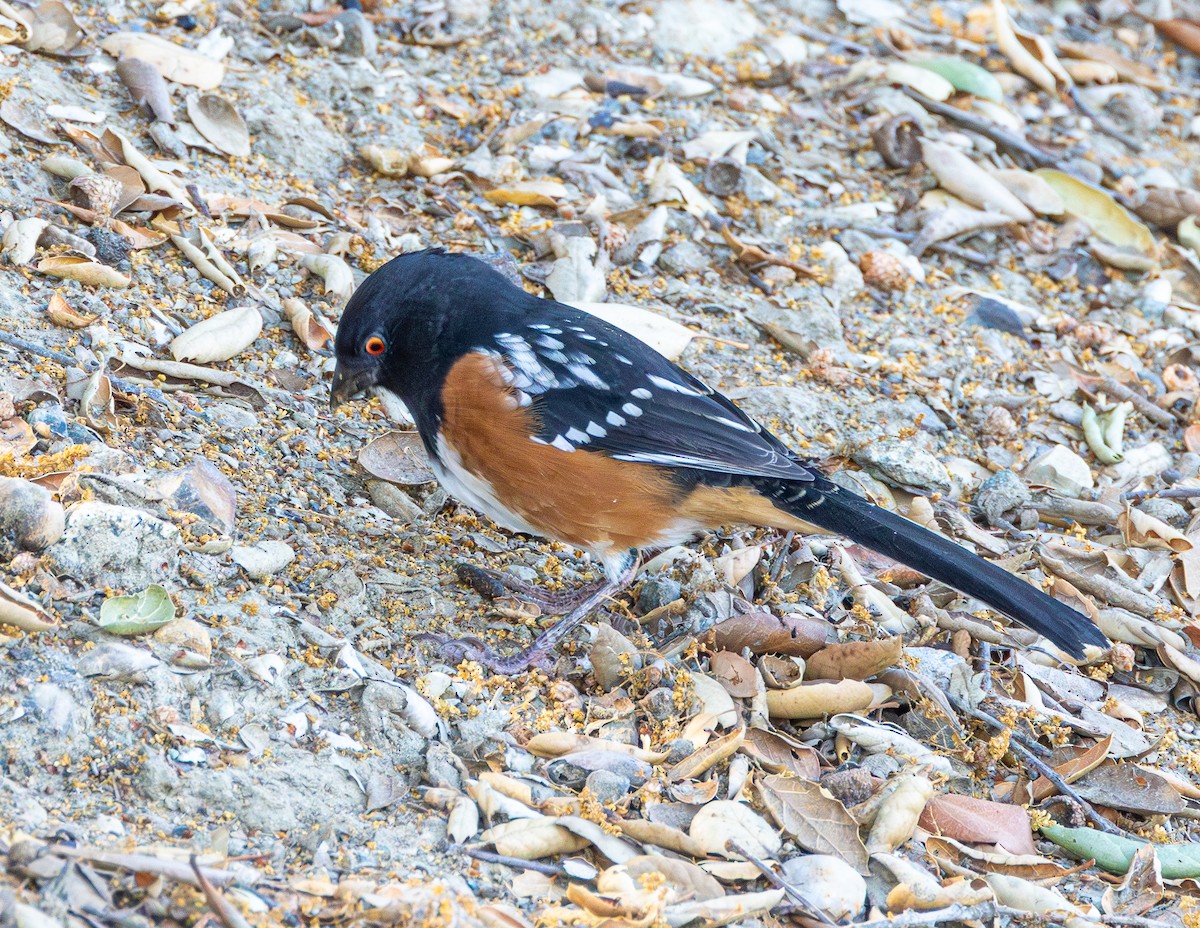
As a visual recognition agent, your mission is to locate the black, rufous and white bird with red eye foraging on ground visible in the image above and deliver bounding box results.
[330,249,1110,673]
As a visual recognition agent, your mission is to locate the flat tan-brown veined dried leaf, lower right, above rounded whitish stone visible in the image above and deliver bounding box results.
[758,774,868,874]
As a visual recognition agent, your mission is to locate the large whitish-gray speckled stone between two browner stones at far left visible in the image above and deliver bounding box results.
[46,502,182,589]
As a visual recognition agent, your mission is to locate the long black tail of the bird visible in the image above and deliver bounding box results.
[755,478,1110,658]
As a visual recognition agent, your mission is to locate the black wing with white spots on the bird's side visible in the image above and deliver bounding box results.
[481,300,814,480]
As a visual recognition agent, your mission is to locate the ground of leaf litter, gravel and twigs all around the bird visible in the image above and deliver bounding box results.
[9,0,1200,928]
